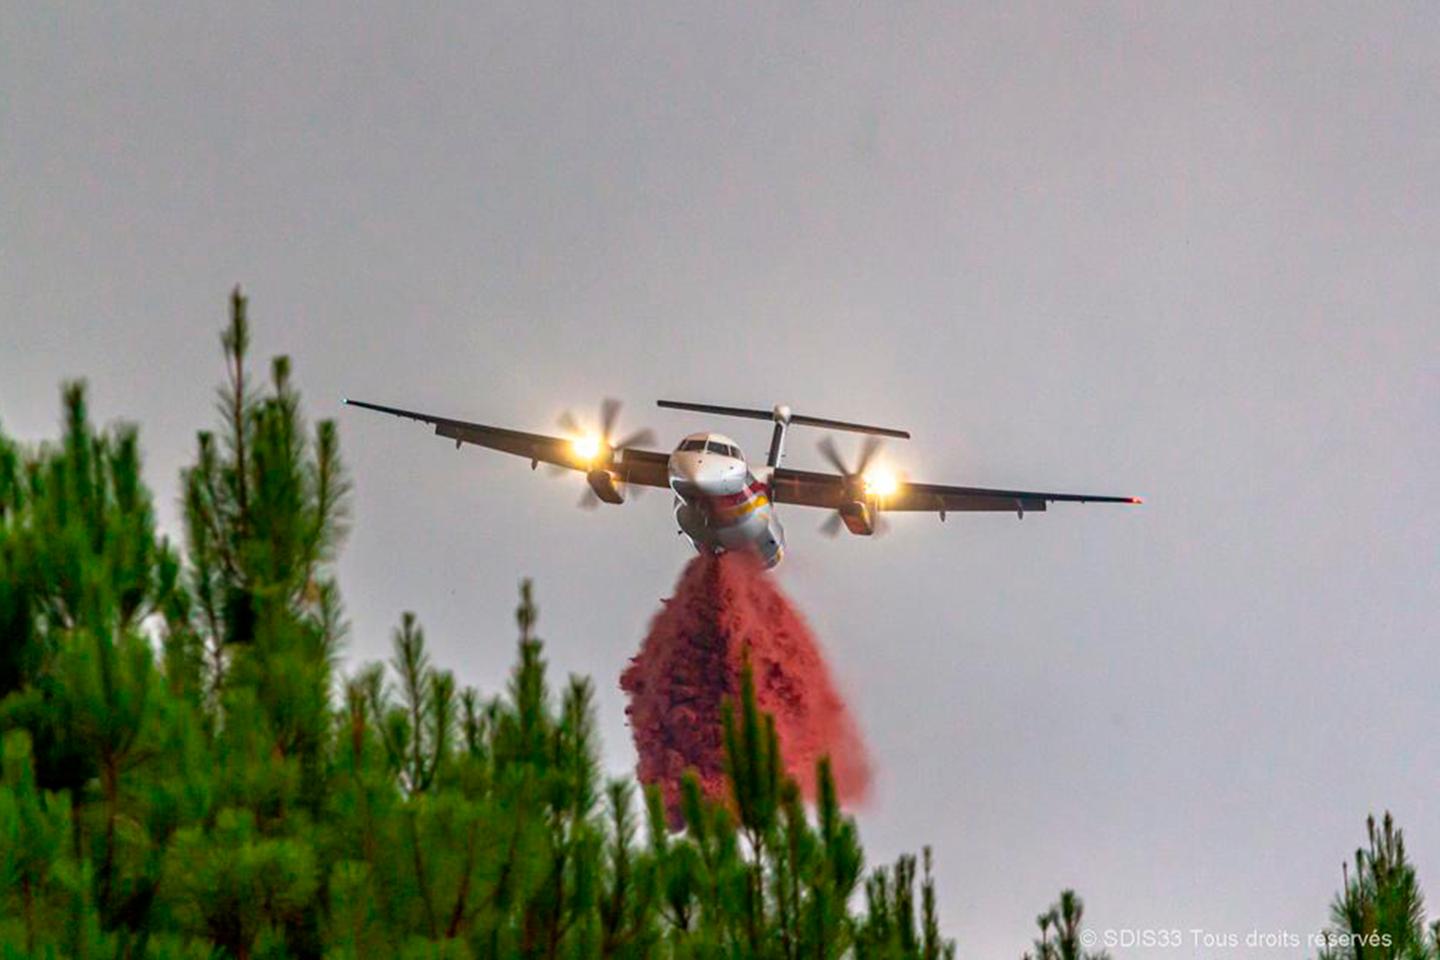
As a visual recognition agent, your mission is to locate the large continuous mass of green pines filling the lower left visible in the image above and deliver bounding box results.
[0,291,967,959]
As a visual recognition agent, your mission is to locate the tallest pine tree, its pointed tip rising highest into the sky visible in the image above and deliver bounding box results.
[167,289,348,956]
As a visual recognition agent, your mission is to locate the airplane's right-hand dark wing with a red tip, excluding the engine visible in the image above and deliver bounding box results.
[770,468,1140,514]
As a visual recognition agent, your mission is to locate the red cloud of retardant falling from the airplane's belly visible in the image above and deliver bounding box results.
[621,553,870,826]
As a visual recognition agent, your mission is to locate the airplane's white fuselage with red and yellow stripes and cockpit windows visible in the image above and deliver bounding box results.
[670,433,785,567]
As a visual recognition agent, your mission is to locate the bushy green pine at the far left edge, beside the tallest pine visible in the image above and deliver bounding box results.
[0,383,207,951]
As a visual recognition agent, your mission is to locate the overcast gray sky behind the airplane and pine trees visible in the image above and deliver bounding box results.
[0,3,1440,957]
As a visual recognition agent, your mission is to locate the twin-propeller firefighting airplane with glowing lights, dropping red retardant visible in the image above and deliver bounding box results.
[346,399,1140,567]
